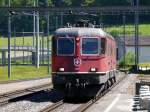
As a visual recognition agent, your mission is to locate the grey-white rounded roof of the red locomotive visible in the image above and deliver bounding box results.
[55,27,113,39]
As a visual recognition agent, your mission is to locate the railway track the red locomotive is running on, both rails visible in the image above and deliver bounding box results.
[40,75,126,112]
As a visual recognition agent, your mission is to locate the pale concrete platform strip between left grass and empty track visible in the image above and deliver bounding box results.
[0,78,51,95]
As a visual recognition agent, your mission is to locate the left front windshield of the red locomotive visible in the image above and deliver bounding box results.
[57,37,74,55]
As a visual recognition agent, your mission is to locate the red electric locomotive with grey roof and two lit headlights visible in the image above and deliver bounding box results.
[52,27,116,96]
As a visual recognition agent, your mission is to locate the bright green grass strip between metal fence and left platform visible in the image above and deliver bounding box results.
[0,66,48,82]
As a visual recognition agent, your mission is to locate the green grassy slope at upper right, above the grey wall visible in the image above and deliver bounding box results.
[106,24,150,36]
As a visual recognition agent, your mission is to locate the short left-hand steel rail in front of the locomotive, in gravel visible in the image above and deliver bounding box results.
[40,100,64,112]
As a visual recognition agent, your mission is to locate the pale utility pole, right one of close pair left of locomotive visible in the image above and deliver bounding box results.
[36,0,40,68]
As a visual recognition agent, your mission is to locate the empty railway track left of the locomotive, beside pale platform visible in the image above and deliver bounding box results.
[0,83,52,106]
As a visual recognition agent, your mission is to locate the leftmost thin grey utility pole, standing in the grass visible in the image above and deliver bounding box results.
[8,0,11,78]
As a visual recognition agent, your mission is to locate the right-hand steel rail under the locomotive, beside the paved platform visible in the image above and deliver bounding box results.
[72,75,126,112]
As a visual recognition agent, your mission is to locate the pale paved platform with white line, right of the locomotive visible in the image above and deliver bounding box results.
[87,74,147,112]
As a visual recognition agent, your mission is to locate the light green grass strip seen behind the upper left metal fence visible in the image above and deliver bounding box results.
[0,36,51,47]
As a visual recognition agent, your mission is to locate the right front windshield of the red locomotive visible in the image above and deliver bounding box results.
[82,38,99,54]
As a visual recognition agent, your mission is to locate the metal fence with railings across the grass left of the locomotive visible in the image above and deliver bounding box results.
[0,32,51,66]
